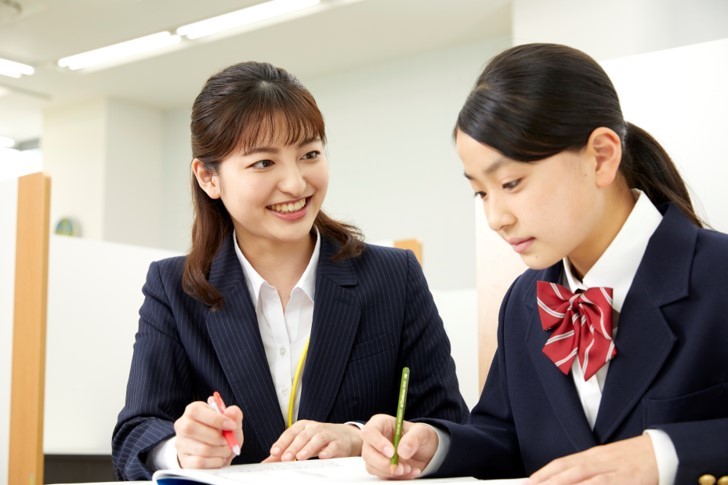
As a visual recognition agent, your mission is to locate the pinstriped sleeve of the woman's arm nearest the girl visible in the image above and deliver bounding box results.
[397,251,468,423]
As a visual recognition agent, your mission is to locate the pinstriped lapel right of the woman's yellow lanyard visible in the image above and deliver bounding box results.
[298,237,361,421]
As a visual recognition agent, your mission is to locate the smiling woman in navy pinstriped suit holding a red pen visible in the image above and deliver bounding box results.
[112,62,468,480]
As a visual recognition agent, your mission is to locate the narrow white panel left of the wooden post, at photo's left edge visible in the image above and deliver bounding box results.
[0,179,18,484]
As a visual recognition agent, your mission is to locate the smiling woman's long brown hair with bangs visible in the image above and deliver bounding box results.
[182,62,364,309]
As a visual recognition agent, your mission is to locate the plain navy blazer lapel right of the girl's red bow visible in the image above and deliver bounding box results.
[594,206,697,443]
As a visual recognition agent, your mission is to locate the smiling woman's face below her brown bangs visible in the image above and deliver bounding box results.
[193,134,329,251]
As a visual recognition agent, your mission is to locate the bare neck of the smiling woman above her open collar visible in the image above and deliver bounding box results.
[240,236,316,310]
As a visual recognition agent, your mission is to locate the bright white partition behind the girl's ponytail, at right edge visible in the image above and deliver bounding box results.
[602,37,728,232]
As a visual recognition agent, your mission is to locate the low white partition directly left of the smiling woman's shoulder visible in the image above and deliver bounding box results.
[43,235,176,454]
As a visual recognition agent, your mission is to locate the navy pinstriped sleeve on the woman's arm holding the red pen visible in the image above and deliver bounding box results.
[112,262,190,480]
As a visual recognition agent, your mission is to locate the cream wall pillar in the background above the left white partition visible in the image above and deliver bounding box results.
[42,99,164,247]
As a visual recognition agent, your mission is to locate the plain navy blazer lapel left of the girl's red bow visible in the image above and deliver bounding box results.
[523,263,597,450]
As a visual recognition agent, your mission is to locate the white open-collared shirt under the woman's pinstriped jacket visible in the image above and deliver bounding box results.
[147,231,321,470]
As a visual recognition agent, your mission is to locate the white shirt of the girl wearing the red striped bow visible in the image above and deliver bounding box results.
[424,190,678,485]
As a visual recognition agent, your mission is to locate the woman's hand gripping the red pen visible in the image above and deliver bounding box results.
[174,395,243,468]
